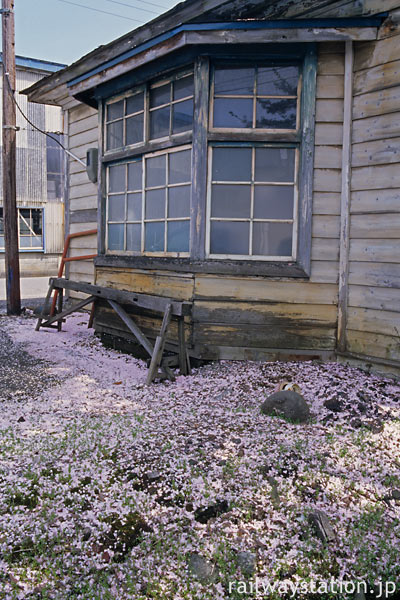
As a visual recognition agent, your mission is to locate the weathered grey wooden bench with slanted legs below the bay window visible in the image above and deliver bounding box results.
[36,277,192,385]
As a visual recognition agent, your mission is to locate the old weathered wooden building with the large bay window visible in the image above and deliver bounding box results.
[22,0,400,374]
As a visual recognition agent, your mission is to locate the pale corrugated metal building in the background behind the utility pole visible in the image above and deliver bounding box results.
[0,56,65,277]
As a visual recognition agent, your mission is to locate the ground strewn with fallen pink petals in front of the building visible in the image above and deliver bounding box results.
[0,311,400,600]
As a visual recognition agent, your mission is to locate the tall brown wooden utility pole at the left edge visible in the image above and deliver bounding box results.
[1,0,21,315]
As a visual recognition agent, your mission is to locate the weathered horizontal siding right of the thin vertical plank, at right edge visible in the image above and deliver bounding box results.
[347,21,400,368]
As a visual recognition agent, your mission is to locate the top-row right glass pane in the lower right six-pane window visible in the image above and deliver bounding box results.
[255,148,295,181]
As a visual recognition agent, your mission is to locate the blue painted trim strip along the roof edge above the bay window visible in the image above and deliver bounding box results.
[67,13,385,87]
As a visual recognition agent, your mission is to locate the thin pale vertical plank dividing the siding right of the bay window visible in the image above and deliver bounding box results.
[337,41,354,352]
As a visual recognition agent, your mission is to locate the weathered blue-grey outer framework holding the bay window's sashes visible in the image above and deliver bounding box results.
[96,43,317,278]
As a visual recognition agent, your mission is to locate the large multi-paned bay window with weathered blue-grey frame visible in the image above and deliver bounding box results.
[103,46,316,275]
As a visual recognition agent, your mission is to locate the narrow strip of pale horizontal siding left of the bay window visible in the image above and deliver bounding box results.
[67,104,98,288]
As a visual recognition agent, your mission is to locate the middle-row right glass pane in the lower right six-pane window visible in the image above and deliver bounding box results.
[254,185,294,219]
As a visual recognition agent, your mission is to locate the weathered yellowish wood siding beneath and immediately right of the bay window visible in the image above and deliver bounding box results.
[96,43,344,359]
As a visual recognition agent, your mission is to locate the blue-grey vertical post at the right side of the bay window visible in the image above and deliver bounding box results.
[297,44,317,275]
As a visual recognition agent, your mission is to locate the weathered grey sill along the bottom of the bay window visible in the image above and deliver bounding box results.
[94,255,309,279]
